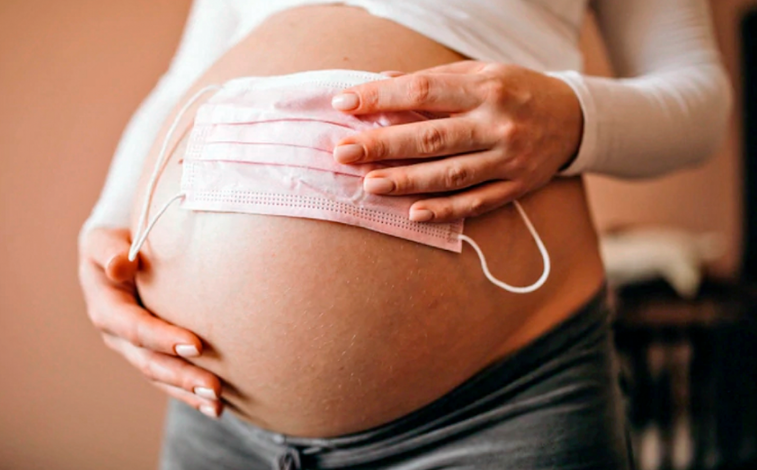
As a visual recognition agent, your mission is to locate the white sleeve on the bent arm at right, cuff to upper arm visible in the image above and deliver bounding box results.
[550,0,733,178]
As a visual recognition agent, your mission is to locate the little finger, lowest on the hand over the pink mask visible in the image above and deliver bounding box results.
[410,181,523,222]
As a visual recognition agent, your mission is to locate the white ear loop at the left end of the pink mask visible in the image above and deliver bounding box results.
[129,85,222,261]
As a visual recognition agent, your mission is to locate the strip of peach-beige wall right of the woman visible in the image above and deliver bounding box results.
[586,0,757,277]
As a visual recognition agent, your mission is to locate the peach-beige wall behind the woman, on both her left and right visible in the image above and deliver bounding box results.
[0,0,754,470]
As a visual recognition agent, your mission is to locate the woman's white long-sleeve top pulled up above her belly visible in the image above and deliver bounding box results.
[85,0,732,228]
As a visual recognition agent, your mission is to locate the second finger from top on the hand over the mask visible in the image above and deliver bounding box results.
[334,117,501,163]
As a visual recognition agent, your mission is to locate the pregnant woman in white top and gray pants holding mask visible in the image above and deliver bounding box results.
[80,0,730,469]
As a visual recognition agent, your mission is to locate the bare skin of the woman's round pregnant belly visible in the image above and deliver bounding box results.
[134,6,602,437]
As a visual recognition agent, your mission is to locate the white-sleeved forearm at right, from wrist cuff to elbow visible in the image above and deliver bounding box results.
[555,65,732,178]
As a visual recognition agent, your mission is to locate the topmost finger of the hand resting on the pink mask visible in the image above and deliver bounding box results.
[331,73,485,114]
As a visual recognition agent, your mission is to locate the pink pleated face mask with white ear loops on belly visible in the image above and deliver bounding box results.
[129,70,550,293]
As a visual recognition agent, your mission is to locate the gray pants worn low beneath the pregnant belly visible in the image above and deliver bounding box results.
[161,290,631,470]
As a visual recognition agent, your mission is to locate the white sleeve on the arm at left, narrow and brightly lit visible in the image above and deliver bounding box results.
[81,0,237,234]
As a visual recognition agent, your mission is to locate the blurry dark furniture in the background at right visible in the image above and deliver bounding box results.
[616,9,757,470]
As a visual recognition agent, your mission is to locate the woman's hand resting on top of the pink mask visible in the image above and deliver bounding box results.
[332,61,583,222]
